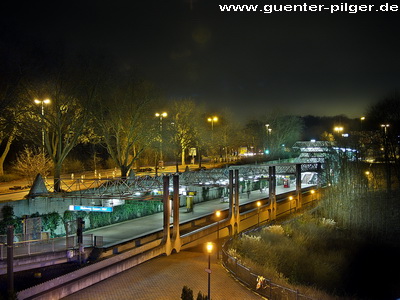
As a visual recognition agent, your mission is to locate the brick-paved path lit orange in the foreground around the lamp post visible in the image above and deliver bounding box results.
[63,248,263,300]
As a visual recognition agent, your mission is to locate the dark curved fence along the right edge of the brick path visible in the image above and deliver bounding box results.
[222,249,313,300]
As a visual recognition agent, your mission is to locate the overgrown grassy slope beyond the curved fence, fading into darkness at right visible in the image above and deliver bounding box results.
[230,216,400,300]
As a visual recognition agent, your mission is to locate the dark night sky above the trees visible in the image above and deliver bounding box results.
[0,0,400,119]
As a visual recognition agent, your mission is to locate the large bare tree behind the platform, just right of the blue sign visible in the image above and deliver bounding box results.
[92,78,156,178]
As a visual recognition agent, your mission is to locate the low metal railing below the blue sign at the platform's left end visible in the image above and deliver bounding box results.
[0,234,94,260]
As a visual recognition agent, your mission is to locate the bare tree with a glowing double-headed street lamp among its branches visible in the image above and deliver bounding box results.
[23,73,90,192]
